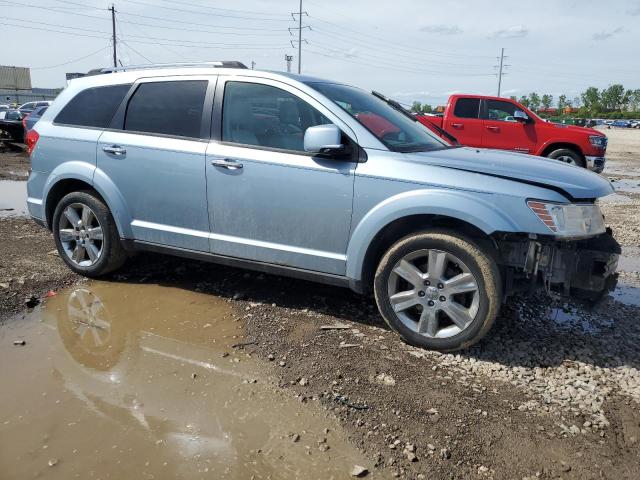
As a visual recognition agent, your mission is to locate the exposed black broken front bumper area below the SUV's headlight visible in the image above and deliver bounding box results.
[497,229,621,301]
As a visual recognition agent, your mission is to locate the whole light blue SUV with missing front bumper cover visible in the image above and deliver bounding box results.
[27,62,620,350]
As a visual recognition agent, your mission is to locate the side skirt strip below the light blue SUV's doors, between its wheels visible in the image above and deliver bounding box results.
[120,239,359,291]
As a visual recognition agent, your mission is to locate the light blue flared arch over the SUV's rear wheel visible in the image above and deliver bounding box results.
[42,161,133,238]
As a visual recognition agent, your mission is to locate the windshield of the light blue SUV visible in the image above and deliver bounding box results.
[309,83,449,152]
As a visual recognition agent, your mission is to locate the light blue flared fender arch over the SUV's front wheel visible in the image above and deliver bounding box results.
[347,190,520,281]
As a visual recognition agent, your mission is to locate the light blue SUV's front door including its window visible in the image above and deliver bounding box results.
[206,78,356,275]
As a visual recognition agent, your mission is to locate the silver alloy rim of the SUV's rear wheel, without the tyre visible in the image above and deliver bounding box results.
[58,203,104,267]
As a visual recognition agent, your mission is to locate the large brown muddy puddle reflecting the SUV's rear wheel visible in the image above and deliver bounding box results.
[0,282,367,480]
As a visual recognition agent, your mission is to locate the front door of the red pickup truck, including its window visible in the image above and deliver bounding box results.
[482,100,537,153]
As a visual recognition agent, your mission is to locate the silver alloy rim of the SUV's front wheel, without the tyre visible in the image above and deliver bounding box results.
[387,249,480,338]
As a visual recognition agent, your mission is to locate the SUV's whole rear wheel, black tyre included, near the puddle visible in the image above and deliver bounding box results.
[52,192,127,278]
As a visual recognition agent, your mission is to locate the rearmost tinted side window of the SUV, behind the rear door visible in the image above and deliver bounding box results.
[54,84,131,128]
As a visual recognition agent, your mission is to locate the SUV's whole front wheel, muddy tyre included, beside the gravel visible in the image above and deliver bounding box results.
[374,230,502,351]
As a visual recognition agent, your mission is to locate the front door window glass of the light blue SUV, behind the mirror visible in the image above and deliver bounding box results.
[222,82,332,152]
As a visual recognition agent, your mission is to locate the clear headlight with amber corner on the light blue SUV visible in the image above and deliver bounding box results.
[527,200,605,237]
